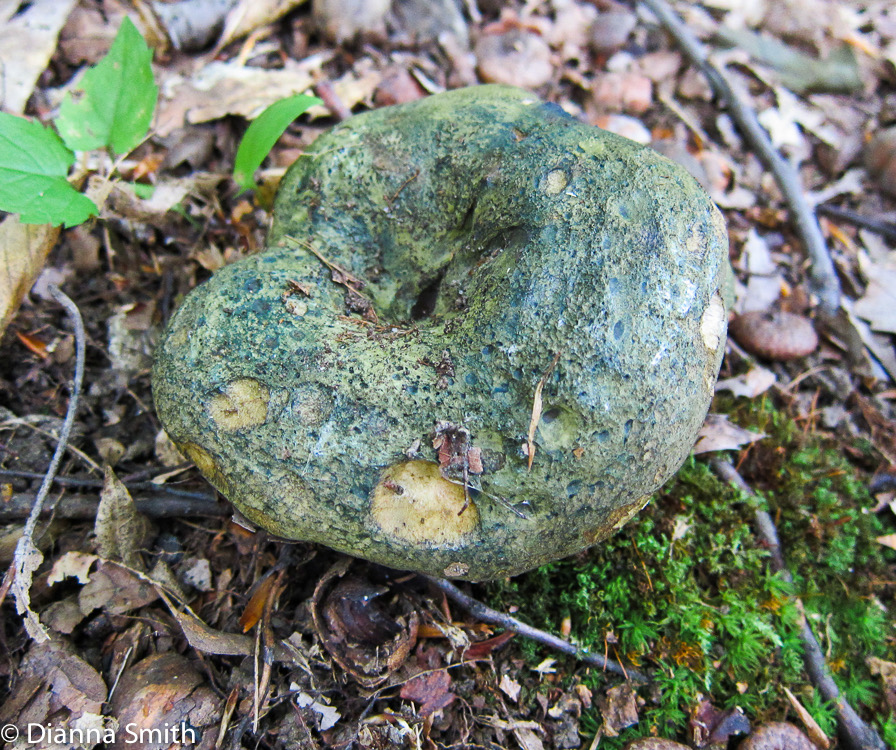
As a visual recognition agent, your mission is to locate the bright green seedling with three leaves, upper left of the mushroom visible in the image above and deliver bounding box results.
[0,18,321,227]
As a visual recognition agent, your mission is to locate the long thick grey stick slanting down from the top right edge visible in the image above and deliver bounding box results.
[640,0,840,320]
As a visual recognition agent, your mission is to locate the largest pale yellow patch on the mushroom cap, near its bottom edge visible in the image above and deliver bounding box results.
[370,461,479,546]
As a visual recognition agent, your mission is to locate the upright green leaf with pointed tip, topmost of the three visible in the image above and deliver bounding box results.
[56,17,159,154]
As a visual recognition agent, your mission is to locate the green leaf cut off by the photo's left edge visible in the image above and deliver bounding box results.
[0,112,99,227]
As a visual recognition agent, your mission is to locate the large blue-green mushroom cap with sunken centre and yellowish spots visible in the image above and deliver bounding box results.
[153,86,728,580]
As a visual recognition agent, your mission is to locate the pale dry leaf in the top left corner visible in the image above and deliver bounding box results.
[0,0,77,114]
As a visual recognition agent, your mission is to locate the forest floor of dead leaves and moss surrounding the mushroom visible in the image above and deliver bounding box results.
[0,0,896,750]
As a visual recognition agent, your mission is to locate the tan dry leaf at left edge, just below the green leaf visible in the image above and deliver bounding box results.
[0,216,59,335]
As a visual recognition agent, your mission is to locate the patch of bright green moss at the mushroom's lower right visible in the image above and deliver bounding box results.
[489,399,896,747]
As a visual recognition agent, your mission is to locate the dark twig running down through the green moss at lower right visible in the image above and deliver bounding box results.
[709,459,887,750]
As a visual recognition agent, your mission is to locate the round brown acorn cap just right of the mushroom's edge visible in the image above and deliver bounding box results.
[728,310,818,362]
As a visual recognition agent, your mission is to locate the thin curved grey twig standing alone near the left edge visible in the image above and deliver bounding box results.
[7,284,87,643]
